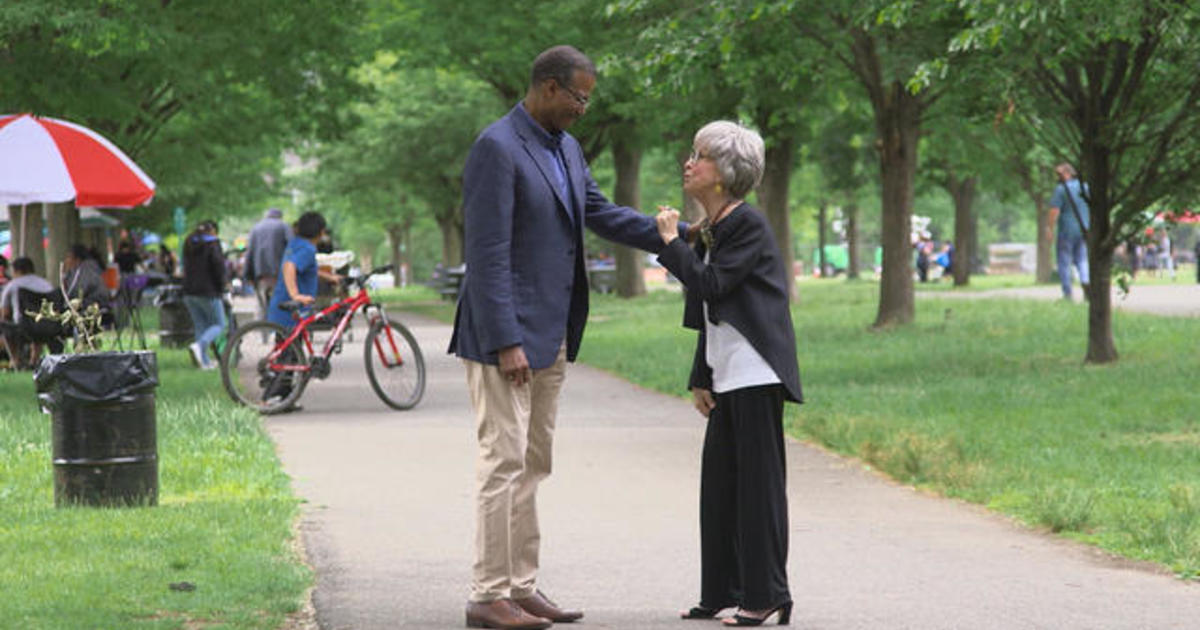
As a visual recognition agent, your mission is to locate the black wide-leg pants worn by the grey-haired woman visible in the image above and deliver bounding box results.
[700,385,791,611]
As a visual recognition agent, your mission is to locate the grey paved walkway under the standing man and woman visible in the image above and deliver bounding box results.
[268,309,1200,630]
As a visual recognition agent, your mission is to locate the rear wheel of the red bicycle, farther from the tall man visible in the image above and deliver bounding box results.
[221,322,308,414]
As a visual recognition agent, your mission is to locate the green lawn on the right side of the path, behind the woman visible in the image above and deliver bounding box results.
[581,282,1200,577]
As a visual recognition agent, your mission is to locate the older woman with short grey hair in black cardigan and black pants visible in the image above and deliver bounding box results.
[658,121,802,625]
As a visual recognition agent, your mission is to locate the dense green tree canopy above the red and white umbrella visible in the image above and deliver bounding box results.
[0,0,362,228]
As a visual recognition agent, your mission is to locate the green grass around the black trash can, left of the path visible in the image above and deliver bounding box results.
[0,329,312,630]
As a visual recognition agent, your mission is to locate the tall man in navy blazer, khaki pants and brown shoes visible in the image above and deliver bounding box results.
[450,46,686,628]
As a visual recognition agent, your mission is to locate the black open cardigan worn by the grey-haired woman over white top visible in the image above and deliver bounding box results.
[659,203,804,402]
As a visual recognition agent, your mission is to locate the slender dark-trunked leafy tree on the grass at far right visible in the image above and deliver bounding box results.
[952,0,1200,362]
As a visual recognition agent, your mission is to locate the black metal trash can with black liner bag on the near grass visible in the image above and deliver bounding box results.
[34,352,158,506]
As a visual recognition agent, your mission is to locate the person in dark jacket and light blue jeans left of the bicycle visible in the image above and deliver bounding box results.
[184,221,227,370]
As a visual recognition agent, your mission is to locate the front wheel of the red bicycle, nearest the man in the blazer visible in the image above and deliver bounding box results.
[362,319,425,409]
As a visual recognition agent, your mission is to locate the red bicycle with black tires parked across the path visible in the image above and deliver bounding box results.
[221,265,425,414]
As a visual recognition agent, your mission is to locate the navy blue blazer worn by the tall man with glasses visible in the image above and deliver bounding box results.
[449,103,685,370]
